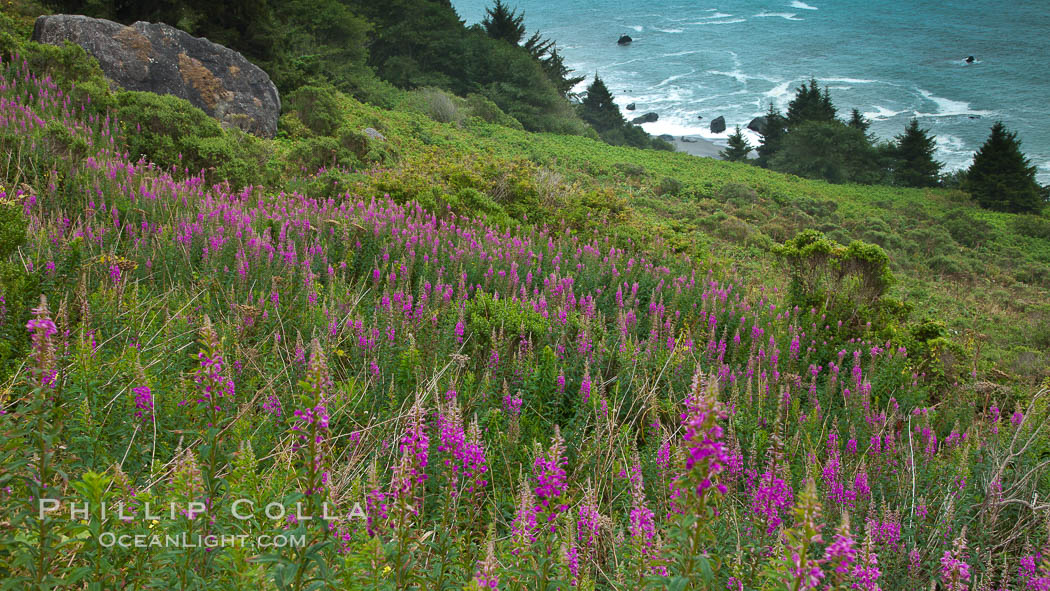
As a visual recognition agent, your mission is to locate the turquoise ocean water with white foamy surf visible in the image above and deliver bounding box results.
[453,0,1050,184]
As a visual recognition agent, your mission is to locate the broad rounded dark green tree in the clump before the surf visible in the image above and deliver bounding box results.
[770,121,881,184]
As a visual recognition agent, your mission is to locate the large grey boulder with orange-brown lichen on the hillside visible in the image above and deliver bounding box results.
[33,15,280,138]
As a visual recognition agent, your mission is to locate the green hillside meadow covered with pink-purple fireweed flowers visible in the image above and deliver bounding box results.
[0,9,1050,590]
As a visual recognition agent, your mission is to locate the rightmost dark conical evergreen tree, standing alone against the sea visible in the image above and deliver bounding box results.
[966,121,1046,213]
